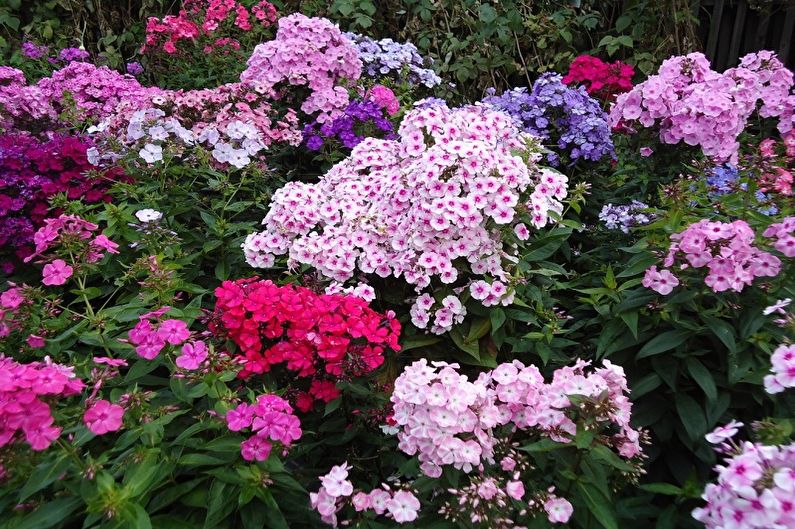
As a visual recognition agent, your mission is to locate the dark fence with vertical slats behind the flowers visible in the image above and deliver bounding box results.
[697,0,795,71]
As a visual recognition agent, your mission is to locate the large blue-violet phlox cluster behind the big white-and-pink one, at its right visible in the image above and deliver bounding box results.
[483,73,615,166]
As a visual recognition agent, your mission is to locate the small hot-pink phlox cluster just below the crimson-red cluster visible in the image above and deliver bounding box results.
[226,395,301,461]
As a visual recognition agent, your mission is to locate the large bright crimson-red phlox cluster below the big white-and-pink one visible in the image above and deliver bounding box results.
[214,279,400,411]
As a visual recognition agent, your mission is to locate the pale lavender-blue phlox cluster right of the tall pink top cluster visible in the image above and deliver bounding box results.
[345,33,442,88]
